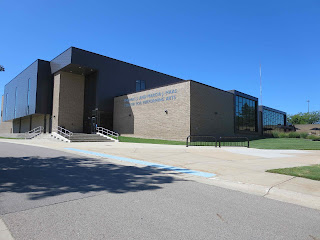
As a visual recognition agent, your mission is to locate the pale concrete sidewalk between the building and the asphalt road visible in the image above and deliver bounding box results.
[0,139,320,210]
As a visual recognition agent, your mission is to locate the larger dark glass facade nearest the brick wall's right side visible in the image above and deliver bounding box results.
[235,96,258,132]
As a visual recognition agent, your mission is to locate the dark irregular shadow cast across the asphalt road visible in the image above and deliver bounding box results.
[0,156,176,200]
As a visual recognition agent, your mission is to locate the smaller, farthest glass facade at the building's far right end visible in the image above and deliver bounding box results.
[262,109,286,133]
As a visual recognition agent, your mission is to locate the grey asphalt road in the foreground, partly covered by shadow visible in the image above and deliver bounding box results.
[0,143,320,240]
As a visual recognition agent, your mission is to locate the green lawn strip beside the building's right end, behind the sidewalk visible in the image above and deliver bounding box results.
[250,138,320,150]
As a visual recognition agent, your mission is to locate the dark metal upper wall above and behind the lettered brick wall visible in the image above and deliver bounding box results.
[72,48,183,128]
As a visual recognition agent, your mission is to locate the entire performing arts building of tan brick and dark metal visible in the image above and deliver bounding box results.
[0,47,286,140]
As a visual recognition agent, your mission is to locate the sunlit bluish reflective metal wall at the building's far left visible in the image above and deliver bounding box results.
[3,60,38,121]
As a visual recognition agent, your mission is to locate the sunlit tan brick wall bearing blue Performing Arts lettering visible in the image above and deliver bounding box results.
[113,81,190,141]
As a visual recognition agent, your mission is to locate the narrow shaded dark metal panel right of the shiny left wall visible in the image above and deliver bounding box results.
[36,60,53,114]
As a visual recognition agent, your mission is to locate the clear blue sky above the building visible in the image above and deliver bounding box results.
[0,0,320,114]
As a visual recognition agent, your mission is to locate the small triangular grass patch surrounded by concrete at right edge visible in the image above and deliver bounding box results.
[267,165,320,181]
